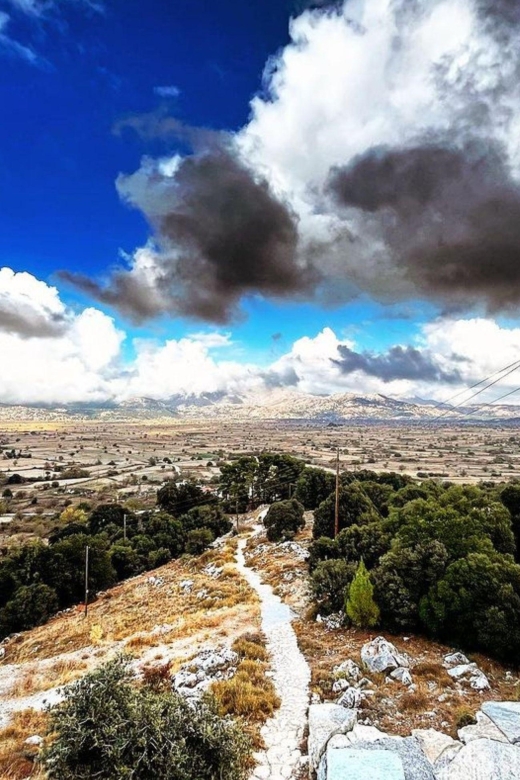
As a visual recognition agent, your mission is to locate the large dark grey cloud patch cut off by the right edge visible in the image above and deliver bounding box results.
[327,140,520,312]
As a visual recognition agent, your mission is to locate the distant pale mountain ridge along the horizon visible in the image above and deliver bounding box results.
[0,389,520,424]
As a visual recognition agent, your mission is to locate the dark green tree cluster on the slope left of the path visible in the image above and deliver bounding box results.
[0,483,231,638]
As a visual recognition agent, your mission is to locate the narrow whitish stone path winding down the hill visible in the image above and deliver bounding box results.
[237,539,310,780]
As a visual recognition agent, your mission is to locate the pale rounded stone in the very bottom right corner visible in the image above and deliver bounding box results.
[436,739,520,780]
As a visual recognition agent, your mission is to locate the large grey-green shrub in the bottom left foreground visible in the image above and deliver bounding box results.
[43,658,250,780]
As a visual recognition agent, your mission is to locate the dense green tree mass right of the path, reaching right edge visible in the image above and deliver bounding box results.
[308,470,520,662]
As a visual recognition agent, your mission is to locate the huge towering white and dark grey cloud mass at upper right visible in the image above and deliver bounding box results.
[64,0,520,324]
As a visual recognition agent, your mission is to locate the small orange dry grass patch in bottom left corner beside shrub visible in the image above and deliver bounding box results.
[0,710,48,780]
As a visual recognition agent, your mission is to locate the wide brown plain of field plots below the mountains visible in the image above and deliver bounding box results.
[0,420,520,533]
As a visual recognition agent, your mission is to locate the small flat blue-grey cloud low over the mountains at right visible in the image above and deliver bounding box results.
[332,345,462,384]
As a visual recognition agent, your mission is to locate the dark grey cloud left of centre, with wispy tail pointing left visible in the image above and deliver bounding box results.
[62,141,318,323]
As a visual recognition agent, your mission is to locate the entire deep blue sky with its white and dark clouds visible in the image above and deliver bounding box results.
[0,0,520,404]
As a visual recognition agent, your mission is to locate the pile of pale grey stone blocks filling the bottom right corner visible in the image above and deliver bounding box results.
[309,702,520,780]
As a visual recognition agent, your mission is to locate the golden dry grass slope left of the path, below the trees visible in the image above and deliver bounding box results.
[3,540,258,663]
